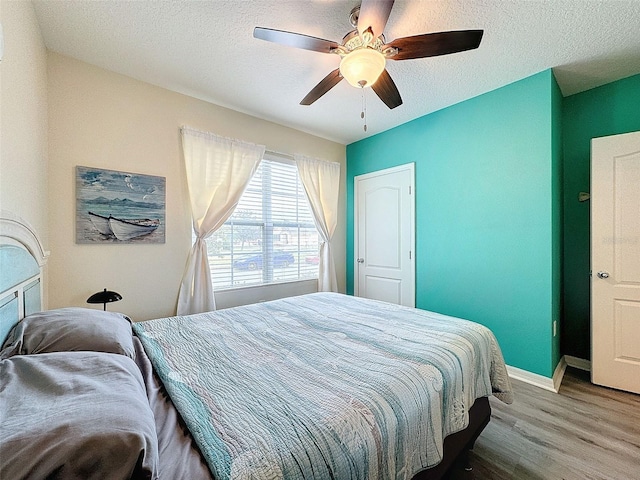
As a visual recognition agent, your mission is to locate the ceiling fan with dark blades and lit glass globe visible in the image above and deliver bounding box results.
[253,0,483,108]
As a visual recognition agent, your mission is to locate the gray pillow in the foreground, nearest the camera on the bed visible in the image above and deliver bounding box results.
[0,352,158,480]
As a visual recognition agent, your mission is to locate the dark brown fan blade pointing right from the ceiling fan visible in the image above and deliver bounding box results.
[385,30,484,60]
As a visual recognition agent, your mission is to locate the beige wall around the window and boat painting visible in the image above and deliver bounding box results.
[48,52,346,320]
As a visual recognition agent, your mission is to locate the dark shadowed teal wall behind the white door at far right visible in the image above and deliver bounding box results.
[562,75,640,359]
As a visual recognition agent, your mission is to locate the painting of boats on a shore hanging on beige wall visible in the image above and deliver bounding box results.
[76,166,166,244]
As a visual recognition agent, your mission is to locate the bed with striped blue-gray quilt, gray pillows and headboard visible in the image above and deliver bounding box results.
[0,215,512,480]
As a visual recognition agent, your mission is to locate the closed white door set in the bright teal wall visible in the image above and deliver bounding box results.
[354,163,415,307]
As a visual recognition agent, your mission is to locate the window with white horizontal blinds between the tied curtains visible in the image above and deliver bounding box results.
[207,157,319,289]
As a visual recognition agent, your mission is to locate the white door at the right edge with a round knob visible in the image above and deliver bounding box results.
[591,132,640,393]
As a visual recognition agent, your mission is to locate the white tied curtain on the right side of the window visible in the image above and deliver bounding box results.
[294,155,340,292]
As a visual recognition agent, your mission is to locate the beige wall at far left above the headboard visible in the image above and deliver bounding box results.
[0,1,50,305]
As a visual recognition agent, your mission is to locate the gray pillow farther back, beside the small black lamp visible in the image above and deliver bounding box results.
[0,307,135,359]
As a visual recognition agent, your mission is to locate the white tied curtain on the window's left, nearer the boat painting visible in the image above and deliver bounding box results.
[178,127,265,315]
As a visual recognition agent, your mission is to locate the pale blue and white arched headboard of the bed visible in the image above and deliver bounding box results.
[0,211,49,345]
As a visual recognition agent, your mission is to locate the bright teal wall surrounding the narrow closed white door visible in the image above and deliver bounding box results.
[347,70,562,377]
